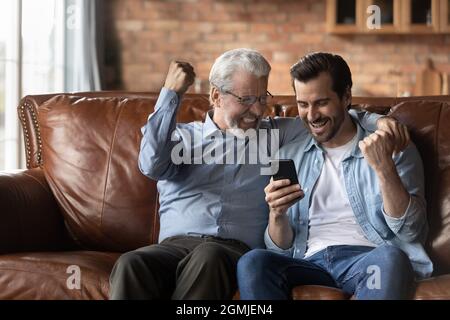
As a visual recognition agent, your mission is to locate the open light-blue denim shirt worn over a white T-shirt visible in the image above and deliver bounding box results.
[264,121,433,278]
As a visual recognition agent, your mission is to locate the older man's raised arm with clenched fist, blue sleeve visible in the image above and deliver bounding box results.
[139,62,195,180]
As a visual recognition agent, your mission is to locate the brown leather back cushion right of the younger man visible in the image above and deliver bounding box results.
[391,101,450,275]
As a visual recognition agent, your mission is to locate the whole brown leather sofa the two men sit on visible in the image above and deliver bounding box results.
[0,92,450,299]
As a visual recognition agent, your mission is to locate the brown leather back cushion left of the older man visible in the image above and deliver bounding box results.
[38,95,162,252]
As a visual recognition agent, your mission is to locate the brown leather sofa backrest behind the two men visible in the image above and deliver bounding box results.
[18,92,450,273]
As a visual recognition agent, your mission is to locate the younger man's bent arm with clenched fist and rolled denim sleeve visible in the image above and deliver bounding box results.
[359,130,427,242]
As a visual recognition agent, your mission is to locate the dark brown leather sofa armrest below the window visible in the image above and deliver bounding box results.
[0,168,73,254]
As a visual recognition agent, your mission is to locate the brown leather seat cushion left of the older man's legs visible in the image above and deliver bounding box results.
[0,251,120,300]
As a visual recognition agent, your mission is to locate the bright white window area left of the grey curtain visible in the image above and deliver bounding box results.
[0,0,64,170]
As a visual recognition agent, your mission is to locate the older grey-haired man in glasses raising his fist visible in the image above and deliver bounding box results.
[110,49,408,299]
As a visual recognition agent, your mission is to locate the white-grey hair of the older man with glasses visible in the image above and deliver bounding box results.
[209,48,271,91]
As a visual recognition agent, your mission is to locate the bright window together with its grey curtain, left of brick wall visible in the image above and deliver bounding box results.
[0,0,102,171]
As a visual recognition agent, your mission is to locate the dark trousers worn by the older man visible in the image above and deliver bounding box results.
[109,236,249,300]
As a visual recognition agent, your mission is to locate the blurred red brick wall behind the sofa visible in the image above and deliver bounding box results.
[105,0,450,96]
